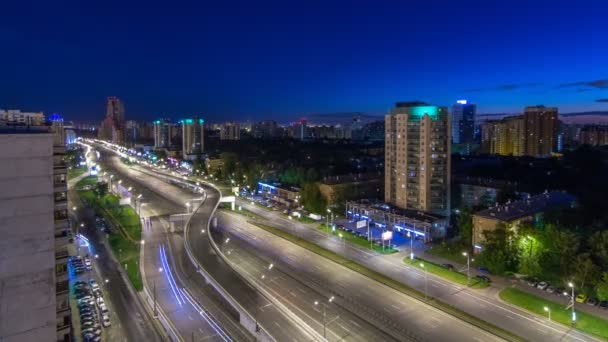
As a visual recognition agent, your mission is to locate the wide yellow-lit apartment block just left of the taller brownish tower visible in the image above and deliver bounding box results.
[481,116,525,157]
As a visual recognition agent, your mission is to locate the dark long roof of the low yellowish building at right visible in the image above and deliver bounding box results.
[475,191,576,222]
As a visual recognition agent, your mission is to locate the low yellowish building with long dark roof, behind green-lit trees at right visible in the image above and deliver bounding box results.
[473,191,576,252]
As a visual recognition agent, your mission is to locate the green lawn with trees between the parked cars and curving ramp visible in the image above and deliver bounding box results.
[78,190,143,291]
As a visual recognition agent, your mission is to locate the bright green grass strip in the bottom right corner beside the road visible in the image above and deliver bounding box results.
[499,287,608,340]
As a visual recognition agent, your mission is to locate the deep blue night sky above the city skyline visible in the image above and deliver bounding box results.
[0,0,608,122]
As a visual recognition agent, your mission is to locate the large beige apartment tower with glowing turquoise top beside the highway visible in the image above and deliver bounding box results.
[384,102,451,216]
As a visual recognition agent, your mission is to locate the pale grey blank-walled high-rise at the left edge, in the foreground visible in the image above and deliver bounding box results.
[0,117,72,341]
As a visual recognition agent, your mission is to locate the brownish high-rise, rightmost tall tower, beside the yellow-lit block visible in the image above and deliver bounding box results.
[524,106,559,157]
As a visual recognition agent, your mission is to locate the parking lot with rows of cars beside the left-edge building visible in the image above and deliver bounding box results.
[69,235,121,342]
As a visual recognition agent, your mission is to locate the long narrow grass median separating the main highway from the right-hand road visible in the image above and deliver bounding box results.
[249,221,524,341]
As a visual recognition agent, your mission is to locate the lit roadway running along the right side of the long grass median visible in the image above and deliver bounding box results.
[233,201,601,342]
